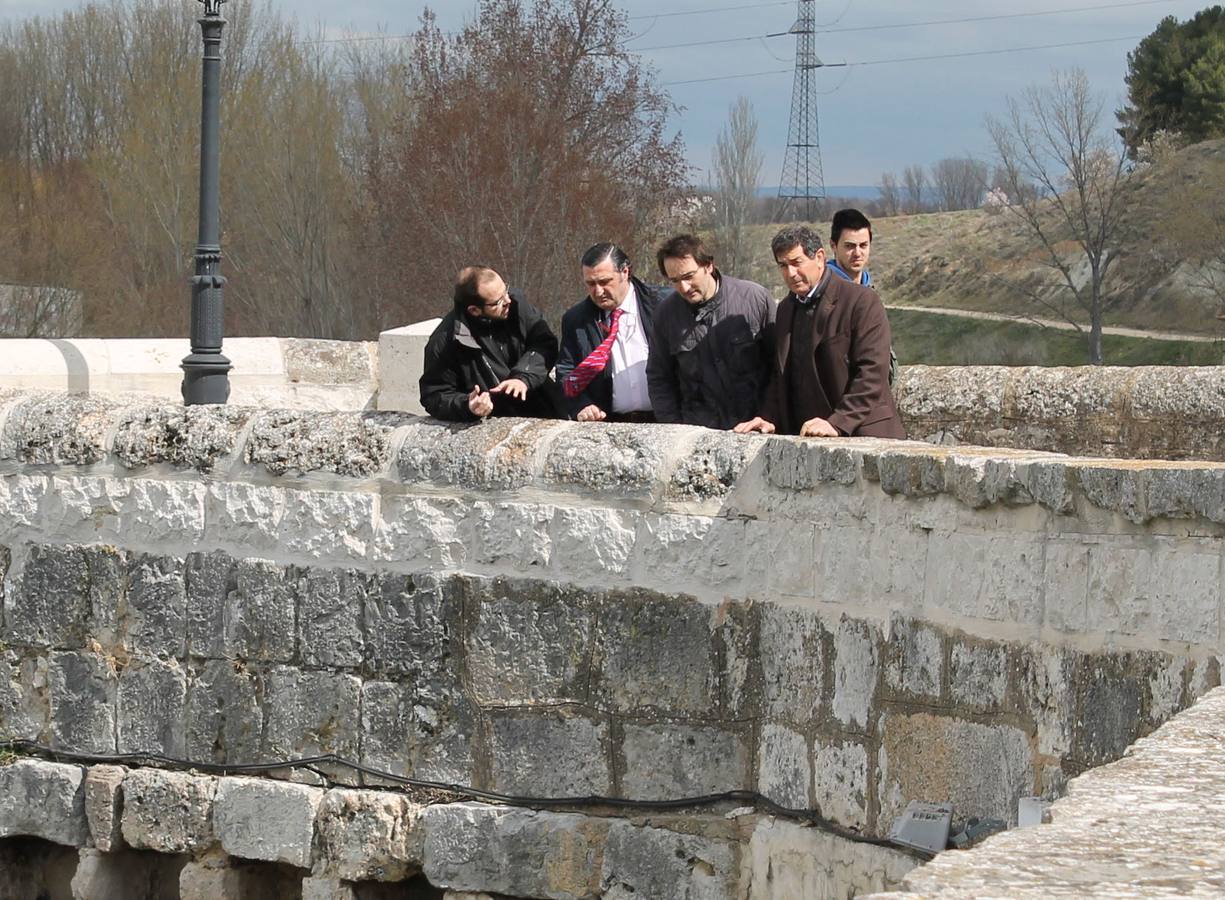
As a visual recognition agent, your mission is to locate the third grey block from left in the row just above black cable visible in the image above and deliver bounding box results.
[115,659,187,757]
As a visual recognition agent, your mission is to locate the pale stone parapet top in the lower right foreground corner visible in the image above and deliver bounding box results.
[873,688,1225,900]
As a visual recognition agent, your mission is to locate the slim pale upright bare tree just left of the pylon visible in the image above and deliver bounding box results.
[714,97,764,272]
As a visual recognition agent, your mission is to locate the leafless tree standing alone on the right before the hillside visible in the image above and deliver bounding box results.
[987,69,1127,365]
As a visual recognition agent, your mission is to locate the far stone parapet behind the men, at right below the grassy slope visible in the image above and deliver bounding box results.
[898,366,1225,460]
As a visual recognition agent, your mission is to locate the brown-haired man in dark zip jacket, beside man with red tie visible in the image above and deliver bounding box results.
[647,234,775,429]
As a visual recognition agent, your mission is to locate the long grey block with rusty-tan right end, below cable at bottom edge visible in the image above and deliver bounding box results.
[423,803,610,900]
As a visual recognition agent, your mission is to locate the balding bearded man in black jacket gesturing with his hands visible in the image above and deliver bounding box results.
[420,266,559,421]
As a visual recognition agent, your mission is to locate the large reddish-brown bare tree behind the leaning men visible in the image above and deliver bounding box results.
[370,0,688,321]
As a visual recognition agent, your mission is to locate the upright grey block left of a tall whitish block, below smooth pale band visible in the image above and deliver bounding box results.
[757,604,826,726]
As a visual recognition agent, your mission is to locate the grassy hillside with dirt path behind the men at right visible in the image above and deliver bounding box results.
[736,141,1225,365]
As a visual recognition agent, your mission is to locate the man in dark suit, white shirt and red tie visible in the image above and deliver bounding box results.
[557,244,665,422]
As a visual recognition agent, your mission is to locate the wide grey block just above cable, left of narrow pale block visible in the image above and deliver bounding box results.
[621,722,750,800]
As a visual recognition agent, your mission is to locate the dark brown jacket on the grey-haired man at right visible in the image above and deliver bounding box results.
[762,272,907,437]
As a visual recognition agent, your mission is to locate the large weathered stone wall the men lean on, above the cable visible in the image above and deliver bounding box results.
[0,397,1225,896]
